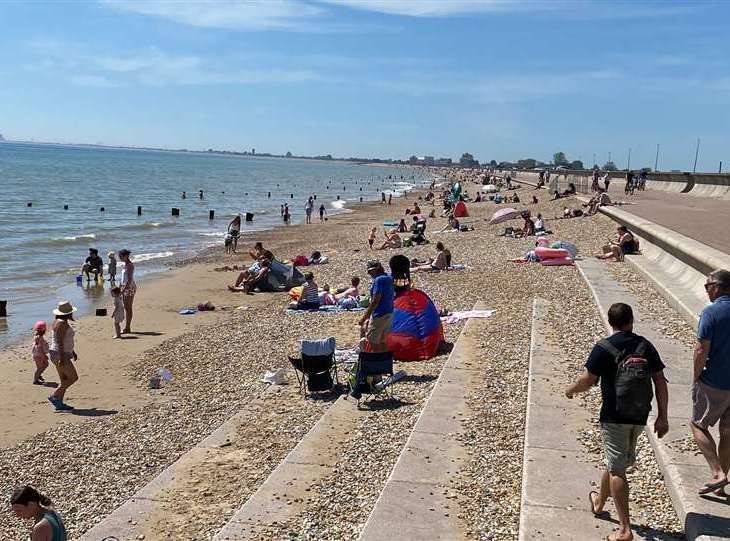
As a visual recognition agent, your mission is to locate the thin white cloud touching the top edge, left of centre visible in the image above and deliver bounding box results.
[101,0,323,30]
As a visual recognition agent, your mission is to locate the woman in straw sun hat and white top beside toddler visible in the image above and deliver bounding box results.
[48,301,79,411]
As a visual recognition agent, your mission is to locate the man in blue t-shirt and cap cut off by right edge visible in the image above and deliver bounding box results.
[690,270,730,497]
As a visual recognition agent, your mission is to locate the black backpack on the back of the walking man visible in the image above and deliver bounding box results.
[598,339,654,424]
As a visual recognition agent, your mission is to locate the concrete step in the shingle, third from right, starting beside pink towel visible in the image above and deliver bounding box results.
[360,303,488,541]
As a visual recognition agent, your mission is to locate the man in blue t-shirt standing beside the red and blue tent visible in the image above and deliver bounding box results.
[359,260,394,353]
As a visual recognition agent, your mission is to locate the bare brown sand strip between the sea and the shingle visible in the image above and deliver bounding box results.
[0,179,432,448]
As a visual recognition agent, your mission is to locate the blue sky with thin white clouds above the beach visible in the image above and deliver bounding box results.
[0,0,730,171]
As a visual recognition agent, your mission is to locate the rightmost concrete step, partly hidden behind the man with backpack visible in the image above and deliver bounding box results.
[577,259,730,541]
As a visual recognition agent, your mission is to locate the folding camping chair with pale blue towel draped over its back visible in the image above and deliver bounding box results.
[289,336,339,398]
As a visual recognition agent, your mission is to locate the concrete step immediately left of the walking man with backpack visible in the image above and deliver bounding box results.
[519,299,614,541]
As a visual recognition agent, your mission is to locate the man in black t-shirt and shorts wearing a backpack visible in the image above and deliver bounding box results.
[565,303,669,541]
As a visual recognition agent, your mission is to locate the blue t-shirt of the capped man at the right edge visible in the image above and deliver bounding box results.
[697,295,730,391]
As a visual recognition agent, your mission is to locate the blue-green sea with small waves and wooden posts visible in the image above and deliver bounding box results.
[0,142,431,350]
